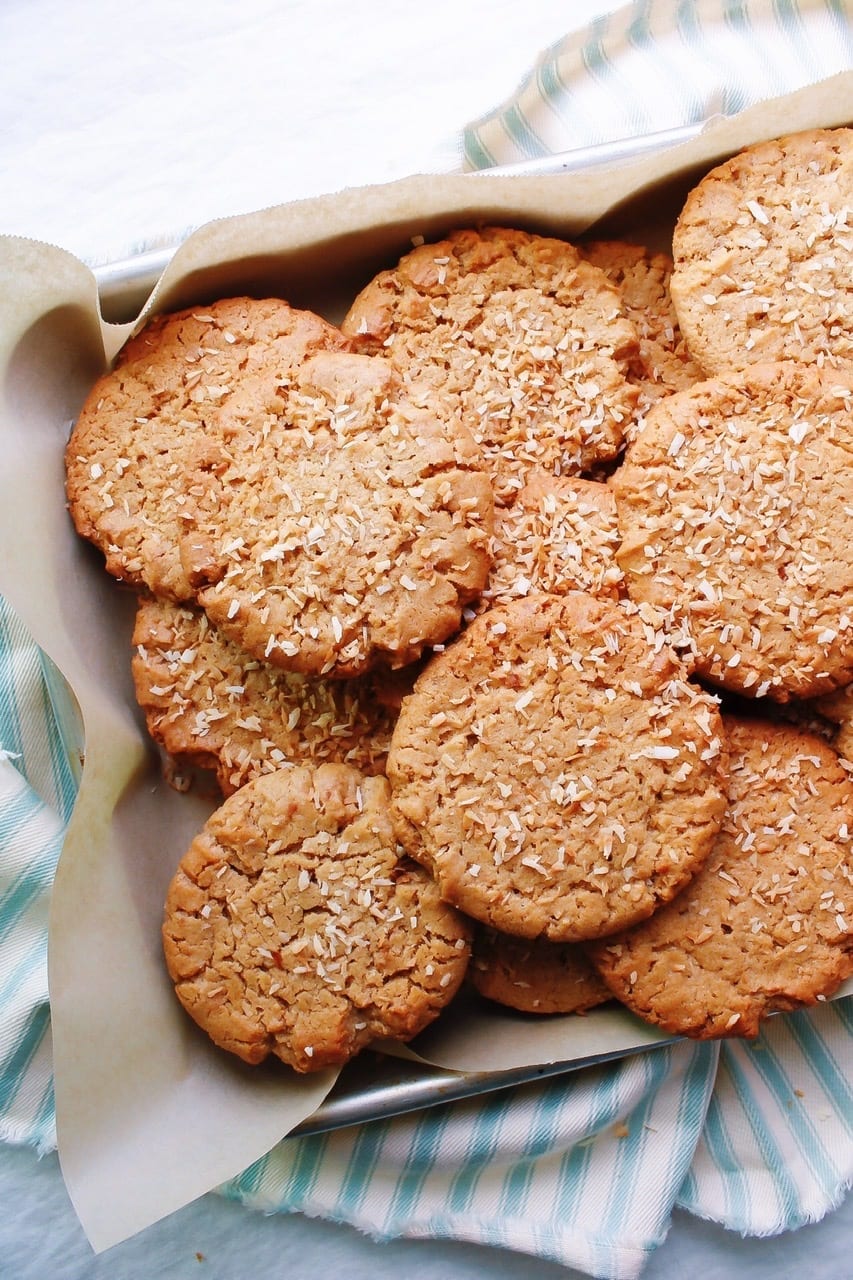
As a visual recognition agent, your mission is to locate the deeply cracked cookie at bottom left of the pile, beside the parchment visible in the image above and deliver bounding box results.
[163,764,470,1071]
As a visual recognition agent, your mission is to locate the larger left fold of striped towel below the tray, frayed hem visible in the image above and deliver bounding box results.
[220,1043,719,1277]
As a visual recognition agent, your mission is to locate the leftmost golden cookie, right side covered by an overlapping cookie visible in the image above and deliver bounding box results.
[65,298,350,600]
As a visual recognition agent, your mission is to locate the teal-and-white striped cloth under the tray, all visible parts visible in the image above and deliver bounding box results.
[0,0,853,1280]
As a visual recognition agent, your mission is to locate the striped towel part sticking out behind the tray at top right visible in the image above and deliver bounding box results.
[460,0,853,169]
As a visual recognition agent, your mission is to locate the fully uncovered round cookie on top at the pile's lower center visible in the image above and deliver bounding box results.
[387,591,725,942]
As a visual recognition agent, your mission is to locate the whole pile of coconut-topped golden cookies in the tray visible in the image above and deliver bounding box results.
[67,129,853,1071]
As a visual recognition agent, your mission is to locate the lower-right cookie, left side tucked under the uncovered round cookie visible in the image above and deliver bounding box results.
[589,717,853,1039]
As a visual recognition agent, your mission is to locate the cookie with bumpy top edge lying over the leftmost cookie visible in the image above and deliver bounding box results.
[184,352,493,678]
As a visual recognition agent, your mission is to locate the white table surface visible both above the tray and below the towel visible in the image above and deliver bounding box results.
[0,0,853,1280]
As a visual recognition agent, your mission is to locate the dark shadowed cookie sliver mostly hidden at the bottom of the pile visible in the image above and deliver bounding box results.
[467,928,612,1014]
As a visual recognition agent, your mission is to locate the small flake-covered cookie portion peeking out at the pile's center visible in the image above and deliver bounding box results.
[482,471,622,605]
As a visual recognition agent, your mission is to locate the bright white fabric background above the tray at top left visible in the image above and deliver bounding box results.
[0,0,607,261]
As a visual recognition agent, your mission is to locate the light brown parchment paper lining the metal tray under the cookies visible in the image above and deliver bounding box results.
[0,74,853,1249]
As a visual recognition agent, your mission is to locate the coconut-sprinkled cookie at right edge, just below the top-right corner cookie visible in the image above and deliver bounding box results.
[612,361,853,701]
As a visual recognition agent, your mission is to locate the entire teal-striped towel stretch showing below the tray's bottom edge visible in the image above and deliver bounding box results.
[220,998,853,1280]
